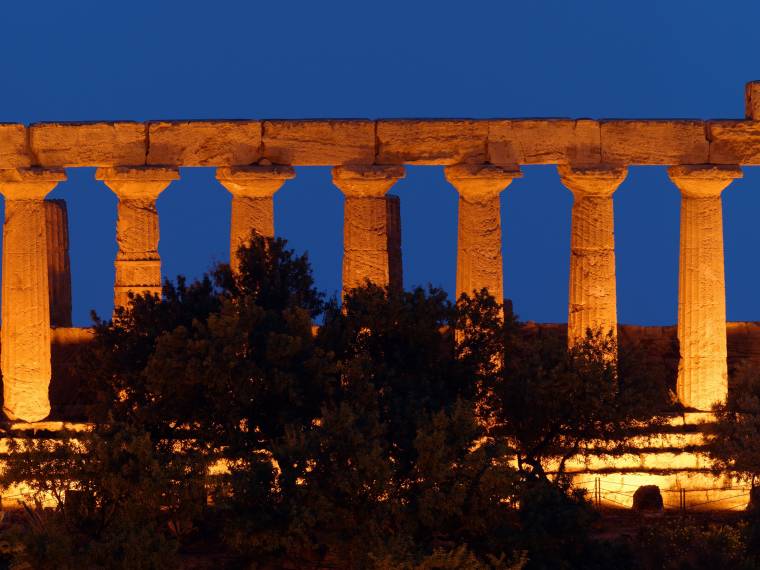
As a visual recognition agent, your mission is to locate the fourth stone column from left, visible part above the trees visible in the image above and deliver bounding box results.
[333,166,404,291]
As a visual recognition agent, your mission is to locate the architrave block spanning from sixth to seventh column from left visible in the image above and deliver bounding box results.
[601,120,709,165]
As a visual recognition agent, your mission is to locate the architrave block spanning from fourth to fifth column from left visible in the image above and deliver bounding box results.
[377,119,489,165]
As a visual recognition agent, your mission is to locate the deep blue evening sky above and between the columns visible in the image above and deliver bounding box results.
[0,0,760,325]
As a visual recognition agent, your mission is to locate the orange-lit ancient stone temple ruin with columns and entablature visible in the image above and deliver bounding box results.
[0,82,760,504]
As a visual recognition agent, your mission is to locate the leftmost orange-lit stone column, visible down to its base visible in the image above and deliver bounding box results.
[0,169,66,422]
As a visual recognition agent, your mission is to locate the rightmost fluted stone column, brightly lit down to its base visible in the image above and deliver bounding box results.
[668,165,742,410]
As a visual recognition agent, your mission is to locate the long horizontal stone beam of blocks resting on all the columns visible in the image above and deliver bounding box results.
[0,82,760,169]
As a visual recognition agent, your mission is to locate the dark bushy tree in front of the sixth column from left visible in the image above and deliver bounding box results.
[457,291,669,481]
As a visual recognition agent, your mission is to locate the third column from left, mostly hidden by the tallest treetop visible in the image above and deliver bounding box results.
[216,165,295,271]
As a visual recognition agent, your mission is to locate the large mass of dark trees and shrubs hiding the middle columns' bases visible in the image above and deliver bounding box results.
[0,235,672,569]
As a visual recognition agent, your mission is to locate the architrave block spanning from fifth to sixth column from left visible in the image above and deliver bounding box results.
[488,119,601,166]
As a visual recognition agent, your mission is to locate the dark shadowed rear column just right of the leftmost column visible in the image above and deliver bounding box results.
[45,200,71,327]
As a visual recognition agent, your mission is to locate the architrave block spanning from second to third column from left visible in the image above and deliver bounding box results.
[148,121,261,166]
